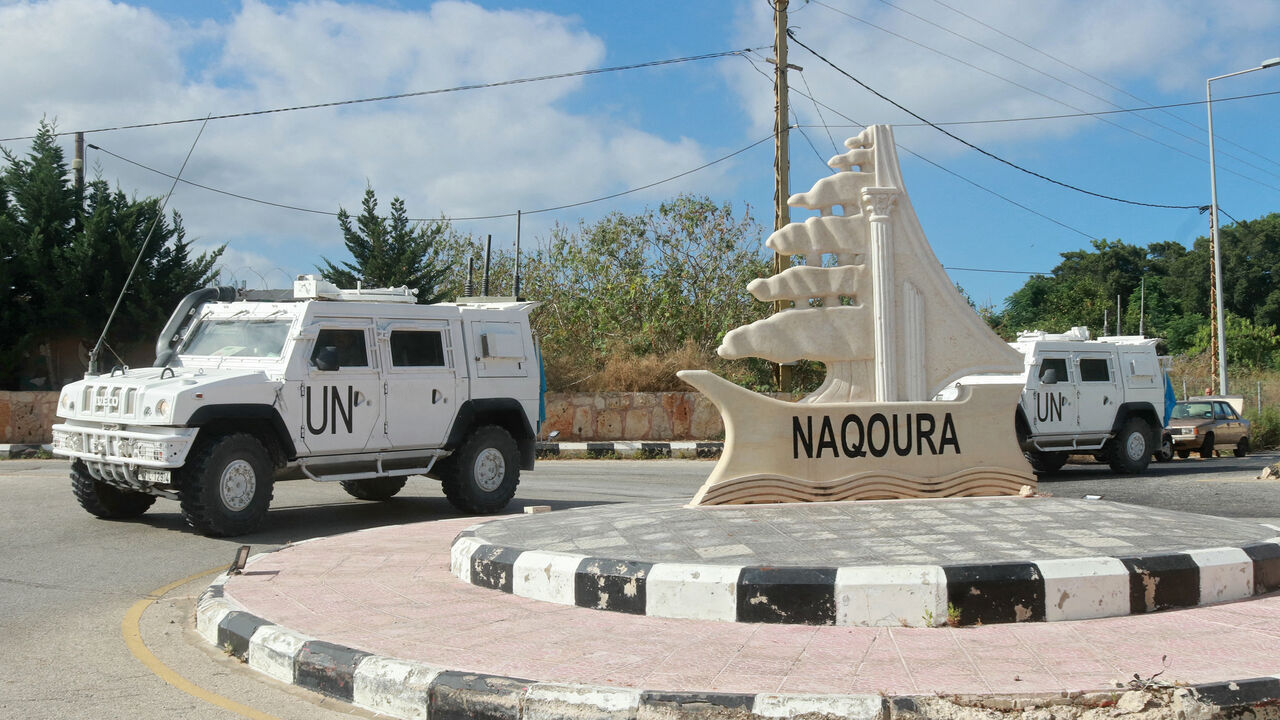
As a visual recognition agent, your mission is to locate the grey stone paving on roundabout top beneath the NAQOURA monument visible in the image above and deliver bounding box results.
[468,498,1275,565]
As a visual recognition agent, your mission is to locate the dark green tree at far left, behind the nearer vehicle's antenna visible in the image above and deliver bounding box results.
[0,122,221,388]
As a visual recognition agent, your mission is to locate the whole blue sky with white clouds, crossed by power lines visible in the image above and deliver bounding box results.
[0,0,1280,312]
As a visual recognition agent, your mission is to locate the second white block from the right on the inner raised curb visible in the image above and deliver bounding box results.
[1036,557,1129,621]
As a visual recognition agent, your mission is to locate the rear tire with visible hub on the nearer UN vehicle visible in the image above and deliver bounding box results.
[442,425,520,515]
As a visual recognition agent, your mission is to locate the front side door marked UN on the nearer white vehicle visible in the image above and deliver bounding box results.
[301,318,383,455]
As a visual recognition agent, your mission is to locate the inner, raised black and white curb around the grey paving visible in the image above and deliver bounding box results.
[449,525,1280,626]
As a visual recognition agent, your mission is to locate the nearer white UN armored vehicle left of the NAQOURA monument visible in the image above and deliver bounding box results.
[54,275,541,536]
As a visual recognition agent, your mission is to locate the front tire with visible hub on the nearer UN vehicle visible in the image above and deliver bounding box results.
[178,433,273,537]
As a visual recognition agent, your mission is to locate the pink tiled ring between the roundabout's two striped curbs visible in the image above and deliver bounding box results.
[225,505,1280,693]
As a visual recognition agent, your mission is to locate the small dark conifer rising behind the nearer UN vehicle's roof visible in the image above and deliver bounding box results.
[316,187,449,304]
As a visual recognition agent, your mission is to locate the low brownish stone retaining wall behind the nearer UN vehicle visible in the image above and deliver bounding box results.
[0,392,768,443]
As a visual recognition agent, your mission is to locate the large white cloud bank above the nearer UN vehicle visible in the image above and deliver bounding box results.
[0,0,724,286]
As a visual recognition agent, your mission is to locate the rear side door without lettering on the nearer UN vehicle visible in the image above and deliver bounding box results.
[378,320,458,450]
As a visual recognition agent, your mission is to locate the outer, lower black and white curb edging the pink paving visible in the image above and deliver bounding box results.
[196,574,1280,720]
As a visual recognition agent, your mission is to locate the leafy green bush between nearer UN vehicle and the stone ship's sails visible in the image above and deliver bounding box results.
[521,195,771,389]
